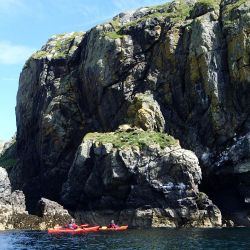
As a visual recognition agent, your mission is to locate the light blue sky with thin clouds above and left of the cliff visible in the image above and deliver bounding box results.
[0,0,167,140]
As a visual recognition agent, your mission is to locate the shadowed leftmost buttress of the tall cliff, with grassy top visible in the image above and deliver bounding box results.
[13,32,84,210]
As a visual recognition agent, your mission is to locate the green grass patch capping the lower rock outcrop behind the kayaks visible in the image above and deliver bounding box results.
[84,130,178,149]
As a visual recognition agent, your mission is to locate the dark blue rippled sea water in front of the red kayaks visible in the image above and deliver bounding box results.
[0,228,250,250]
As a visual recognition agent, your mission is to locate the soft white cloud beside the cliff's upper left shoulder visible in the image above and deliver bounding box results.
[0,41,35,64]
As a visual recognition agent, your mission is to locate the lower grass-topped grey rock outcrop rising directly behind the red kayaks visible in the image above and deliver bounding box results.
[62,130,221,227]
